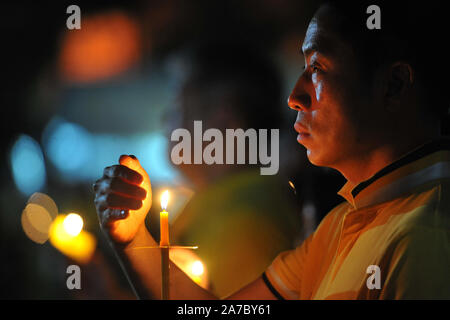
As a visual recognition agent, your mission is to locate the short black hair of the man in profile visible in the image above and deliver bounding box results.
[322,0,449,119]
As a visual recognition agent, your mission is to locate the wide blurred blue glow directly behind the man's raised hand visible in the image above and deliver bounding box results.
[43,118,180,183]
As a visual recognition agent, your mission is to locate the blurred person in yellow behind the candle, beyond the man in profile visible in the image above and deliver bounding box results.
[168,37,301,297]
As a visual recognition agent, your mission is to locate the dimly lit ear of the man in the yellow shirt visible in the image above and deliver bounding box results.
[385,62,414,111]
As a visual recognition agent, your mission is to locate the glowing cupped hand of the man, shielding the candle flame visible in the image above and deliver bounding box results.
[94,155,152,244]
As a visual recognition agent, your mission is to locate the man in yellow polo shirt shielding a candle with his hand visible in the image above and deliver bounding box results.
[96,2,450,299]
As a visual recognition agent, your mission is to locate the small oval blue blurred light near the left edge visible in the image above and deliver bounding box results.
[11,134,46,196]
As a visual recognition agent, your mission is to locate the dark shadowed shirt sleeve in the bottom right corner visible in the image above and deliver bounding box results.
[380,228,450,299]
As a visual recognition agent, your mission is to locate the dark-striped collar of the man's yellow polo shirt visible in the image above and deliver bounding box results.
[338,139,450,209]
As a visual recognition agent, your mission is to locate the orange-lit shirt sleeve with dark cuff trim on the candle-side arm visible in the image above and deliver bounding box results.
[263,234,313,300]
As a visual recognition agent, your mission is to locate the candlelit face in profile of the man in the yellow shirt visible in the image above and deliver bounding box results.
[288,6,384,168]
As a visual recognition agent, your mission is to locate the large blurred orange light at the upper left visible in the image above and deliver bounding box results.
[59,11,141,83]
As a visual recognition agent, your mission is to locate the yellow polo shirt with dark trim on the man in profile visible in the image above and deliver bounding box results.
[263,139,450,299]
